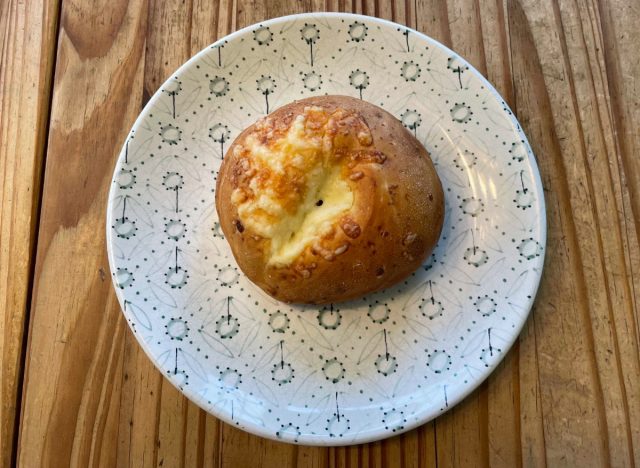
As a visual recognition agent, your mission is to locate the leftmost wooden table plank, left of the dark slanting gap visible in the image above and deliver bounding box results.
[0,1,59,466]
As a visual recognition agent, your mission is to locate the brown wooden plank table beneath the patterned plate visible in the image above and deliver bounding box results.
[0,0,640,468]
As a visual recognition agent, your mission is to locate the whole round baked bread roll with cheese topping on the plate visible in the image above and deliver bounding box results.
[216,96,444,304]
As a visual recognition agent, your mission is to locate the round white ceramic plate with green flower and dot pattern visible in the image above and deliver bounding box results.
[107,13,546,445]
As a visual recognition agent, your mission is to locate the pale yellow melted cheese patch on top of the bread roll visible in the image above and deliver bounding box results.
[231,107,370,266]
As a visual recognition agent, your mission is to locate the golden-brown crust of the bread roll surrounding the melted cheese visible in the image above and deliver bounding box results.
[216,96,444,304]
